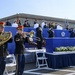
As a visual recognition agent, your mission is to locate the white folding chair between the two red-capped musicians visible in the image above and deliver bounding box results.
[4,54,16,75]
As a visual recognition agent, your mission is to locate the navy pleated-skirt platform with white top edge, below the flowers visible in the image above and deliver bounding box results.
[46,51,75,69]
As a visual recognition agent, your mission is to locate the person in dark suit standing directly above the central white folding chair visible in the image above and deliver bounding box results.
[36,24,43,49]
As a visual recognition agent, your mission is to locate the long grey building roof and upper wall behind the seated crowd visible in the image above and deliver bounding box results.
[0,13,75,28]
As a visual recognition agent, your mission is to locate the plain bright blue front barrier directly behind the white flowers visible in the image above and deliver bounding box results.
[46,37,75,53]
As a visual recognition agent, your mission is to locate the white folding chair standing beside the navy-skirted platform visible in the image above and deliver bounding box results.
[36,50,48,68]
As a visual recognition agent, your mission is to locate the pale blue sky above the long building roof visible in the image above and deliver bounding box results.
[0,0,75,20]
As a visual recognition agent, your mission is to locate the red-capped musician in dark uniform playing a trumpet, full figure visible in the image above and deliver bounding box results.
[14,26,26,75]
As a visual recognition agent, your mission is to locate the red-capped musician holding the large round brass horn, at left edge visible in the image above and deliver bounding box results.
[0,22,12,75]
